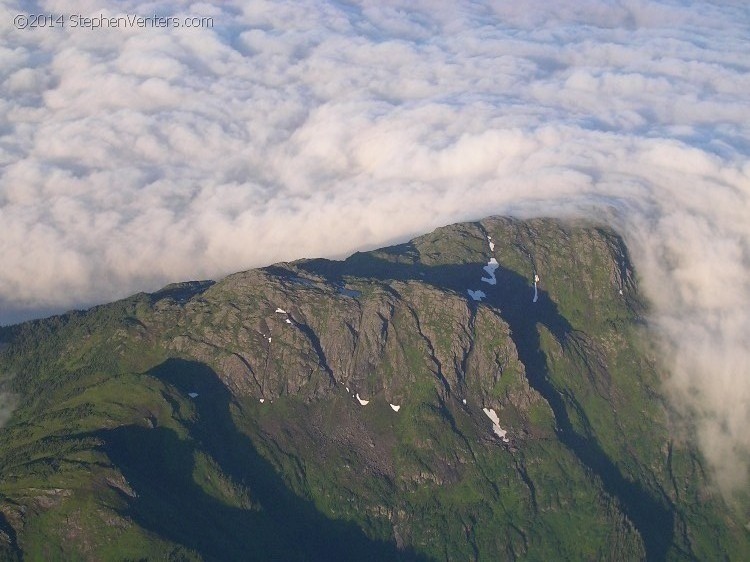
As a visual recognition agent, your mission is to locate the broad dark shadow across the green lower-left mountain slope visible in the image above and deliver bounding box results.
[96,359,427,561]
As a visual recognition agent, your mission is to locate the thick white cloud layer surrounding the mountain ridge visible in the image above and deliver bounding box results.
[0,0,750,495]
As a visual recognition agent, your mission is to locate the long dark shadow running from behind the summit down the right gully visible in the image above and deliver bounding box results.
[295,252,674,561]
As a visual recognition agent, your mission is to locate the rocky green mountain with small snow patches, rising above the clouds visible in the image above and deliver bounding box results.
[0,218,750,560]
